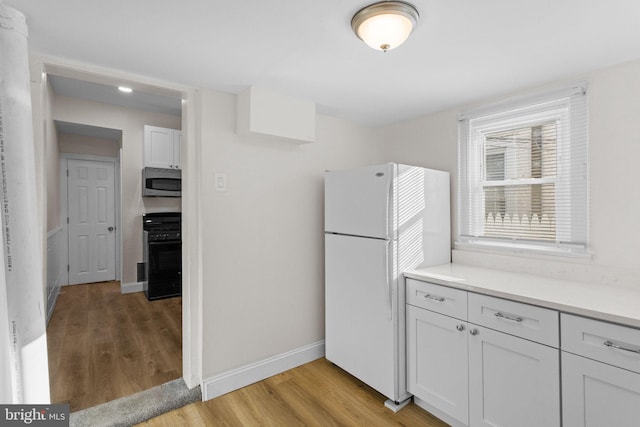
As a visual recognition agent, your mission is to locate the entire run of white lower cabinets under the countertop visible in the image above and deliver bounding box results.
[406,278,640,427]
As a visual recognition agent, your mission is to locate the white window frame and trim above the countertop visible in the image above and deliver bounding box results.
[455,83,588,257]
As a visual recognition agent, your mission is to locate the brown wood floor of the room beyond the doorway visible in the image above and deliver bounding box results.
[47,282,182,412]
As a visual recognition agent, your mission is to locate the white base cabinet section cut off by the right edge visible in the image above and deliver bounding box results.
[561,314,640,427]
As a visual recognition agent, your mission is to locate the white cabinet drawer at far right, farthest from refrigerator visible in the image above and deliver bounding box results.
[561,313,640,373]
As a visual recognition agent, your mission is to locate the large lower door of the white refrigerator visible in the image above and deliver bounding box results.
[325,234,400,401]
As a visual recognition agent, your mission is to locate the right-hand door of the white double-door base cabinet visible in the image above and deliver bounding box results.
[469,324,560,427]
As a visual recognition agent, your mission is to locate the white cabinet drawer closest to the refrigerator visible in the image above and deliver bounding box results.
[406,279,467,320]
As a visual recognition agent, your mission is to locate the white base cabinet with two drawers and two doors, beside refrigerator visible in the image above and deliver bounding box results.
[406,279,561,427]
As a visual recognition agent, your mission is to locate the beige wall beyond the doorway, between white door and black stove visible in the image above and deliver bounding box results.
[53,96,181,283]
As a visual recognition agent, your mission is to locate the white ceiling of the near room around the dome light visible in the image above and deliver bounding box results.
[5,0,640,127]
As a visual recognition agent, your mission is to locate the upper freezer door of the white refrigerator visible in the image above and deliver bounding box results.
[324,163,395,239]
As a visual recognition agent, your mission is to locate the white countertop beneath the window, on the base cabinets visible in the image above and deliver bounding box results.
[404,264,640,328]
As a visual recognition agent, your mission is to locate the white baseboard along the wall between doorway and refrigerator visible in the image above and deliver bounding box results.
[202,340,324,401]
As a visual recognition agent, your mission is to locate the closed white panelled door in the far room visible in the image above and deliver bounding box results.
[67,159,116,285]
